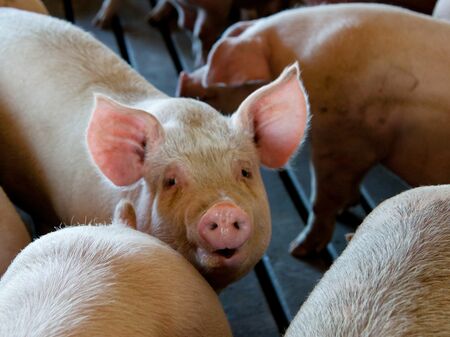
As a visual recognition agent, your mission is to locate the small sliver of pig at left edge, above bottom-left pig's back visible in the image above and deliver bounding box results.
[0,187,31,277]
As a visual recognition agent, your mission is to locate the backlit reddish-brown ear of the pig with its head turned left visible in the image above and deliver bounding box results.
[202,36,272,87]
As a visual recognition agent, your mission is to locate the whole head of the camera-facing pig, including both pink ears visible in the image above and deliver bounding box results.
[87,66,307,289]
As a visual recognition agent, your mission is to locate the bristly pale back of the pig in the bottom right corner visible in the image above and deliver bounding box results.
[285,185,450,337]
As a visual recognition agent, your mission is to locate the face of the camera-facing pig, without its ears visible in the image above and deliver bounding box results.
[145,99,271,289]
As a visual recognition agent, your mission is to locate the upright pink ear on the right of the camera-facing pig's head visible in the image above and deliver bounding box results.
[232,64,309,168]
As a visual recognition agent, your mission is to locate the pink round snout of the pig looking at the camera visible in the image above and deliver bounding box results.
[198,202,252,258]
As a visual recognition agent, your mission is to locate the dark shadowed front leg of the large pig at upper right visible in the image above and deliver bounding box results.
[289,139,377,257]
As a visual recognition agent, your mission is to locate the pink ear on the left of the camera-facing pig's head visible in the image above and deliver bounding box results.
[87,95,163,186]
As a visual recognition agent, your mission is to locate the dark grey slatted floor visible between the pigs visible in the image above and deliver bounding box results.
[38,0,407,337]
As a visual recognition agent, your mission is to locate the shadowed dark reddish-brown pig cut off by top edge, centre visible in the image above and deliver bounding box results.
[93,0,288,65]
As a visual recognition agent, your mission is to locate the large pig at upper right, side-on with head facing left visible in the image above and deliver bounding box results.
[178,4,450,257]
